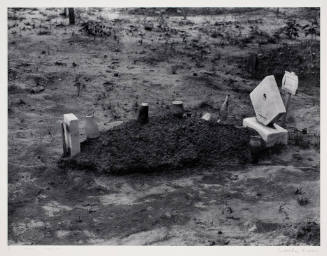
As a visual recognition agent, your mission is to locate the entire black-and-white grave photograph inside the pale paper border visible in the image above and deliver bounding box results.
[7,7,321,246]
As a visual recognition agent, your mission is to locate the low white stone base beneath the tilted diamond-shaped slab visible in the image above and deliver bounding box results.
[243,117,288,147]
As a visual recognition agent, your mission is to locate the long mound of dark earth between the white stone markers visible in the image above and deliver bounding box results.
[59,116,252,174]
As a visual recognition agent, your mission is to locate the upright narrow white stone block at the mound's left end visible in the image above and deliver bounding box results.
[64,113,81,157]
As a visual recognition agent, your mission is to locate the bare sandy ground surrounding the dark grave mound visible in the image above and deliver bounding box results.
[8,8,320,245]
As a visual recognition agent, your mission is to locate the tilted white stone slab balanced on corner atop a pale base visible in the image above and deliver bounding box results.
[250,76,286,125]
